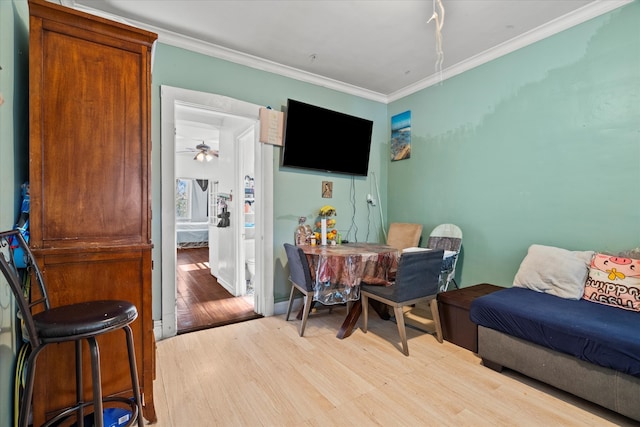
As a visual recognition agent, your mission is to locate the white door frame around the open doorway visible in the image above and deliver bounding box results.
[160,85,274,338]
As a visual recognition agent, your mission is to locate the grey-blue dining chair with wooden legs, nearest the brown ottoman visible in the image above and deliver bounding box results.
[360,249,444,356]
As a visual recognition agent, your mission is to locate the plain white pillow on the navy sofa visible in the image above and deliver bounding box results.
[513,245,594,300]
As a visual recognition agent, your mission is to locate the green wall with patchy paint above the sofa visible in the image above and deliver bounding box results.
[387,1,640,286]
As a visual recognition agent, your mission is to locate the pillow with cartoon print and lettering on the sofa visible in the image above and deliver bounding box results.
[582,253,640,311]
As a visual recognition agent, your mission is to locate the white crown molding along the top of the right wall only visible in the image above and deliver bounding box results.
[387,0,635,102]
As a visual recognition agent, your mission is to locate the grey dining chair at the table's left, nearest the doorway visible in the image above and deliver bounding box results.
[284,243,322,336]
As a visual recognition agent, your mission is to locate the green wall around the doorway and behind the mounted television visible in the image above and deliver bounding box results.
[151,43,389,319]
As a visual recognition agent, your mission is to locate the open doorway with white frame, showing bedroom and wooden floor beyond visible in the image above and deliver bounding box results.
[161,86,273,337]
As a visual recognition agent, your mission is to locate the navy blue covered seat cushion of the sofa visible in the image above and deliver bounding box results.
[469,288,640,377]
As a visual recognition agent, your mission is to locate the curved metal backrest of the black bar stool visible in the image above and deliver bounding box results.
[0,230,49,348]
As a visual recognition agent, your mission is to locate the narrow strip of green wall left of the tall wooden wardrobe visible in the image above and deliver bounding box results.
[0,0,29,426]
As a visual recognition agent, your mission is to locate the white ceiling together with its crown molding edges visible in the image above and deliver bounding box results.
[58,0,632,102]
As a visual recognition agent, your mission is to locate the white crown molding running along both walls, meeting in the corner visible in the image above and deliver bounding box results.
[59,0,635,104]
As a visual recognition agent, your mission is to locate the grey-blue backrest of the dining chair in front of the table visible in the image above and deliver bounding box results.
[391,249,444,302]
